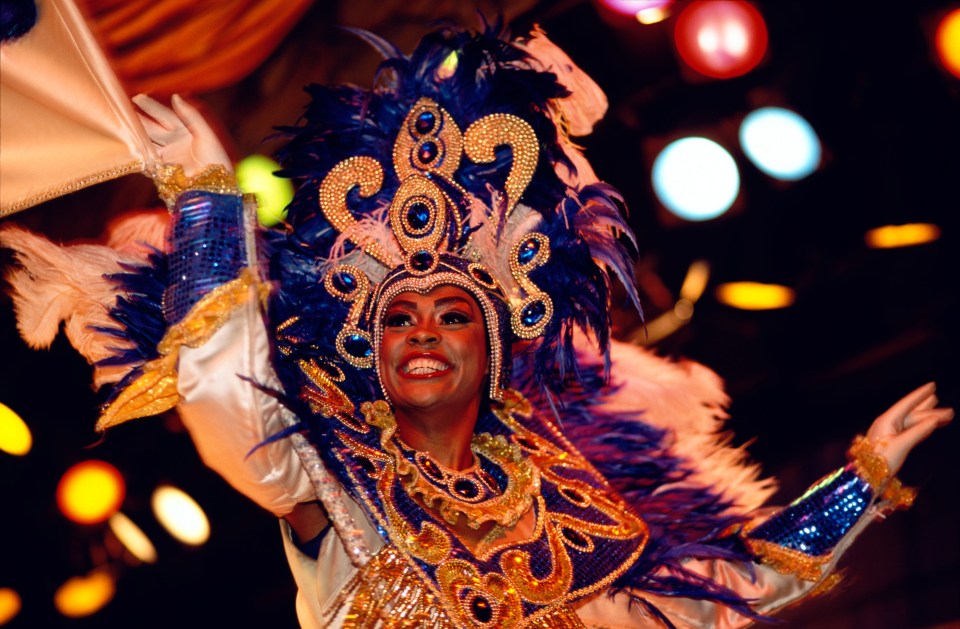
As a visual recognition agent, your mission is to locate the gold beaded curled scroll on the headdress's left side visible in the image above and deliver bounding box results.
[320,155,398,268]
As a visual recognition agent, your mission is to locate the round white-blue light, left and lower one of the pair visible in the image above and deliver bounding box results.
[652,137,740,221]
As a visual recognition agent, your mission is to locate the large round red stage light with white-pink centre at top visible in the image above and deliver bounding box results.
[674,0,768,79]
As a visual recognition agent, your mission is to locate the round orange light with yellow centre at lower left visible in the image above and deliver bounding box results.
[57,461,126,524]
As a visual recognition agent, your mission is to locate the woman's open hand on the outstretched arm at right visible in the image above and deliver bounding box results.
[867,382,953,475]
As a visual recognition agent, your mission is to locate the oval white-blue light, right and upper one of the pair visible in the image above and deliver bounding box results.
[740,107,822,181]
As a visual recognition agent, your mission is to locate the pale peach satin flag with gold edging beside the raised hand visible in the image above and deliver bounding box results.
[0,0,155,217]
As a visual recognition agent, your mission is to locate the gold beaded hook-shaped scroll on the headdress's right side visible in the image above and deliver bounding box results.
[463,114,540,216]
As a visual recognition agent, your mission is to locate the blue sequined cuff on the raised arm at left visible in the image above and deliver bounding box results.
[163,190,247,324]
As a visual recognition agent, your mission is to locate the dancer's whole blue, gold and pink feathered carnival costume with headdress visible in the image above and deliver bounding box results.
[3,20,911,627]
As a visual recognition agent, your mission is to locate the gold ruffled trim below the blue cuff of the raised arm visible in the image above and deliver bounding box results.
[96,269,269,431]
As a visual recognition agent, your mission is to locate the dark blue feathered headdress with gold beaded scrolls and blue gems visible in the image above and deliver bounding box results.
[271,20,639,408]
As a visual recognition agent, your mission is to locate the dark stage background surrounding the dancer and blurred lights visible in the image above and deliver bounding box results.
[0,0,960,628]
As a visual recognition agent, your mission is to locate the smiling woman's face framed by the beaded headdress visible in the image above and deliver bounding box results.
[380,286,489,414]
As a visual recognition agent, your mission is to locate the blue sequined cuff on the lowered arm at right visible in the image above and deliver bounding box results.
[749,468,873,556]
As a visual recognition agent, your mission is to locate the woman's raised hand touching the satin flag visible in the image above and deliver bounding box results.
[133,94,233,177]
